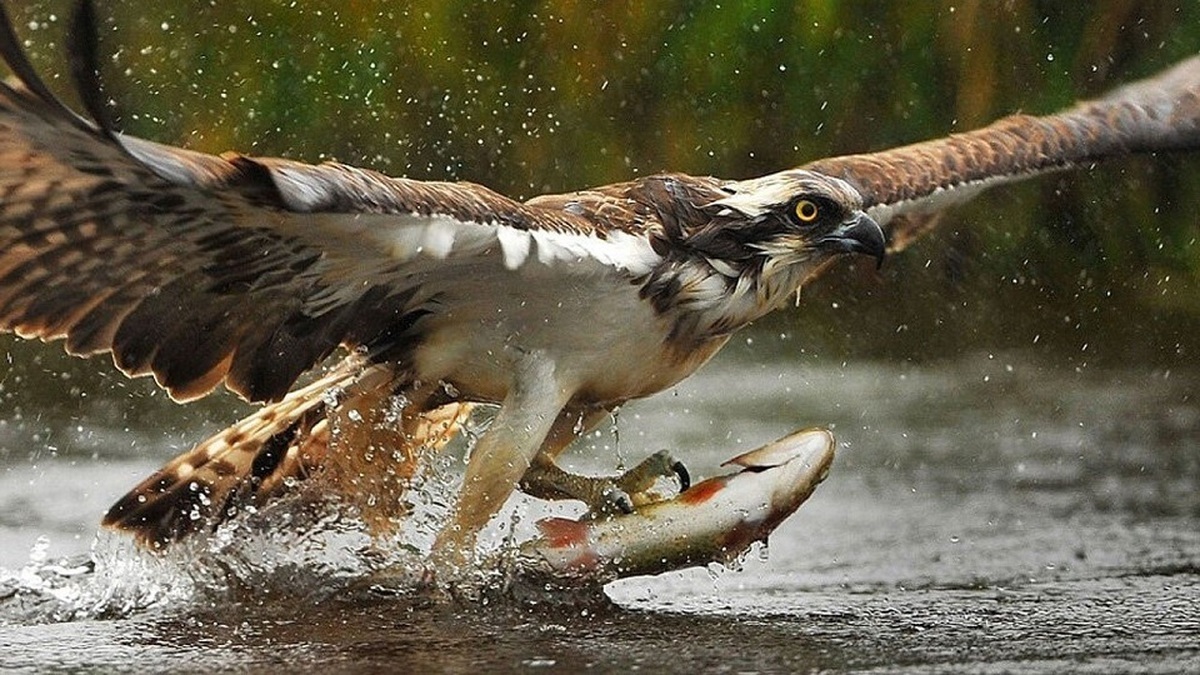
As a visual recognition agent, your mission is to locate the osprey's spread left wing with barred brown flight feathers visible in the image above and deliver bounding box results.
[0,2,657,400]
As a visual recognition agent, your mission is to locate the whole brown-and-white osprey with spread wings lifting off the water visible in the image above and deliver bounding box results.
[0,2,1200,565]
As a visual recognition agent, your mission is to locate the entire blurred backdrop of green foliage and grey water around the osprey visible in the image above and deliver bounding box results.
[0,0,1200,673]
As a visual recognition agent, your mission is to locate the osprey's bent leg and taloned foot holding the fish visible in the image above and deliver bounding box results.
[521,408,690,514]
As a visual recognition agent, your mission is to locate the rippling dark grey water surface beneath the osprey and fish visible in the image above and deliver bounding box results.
[0,353,1200,673]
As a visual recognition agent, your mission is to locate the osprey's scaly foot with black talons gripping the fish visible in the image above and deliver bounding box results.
[521,450,691,516]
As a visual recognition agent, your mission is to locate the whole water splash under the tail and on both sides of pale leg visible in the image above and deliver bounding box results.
[0,401,577,625]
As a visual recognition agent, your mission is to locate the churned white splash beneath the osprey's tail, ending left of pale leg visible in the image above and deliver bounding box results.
[0,483,458,625]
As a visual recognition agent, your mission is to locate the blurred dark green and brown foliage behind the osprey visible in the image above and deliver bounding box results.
[2,0,1200,372]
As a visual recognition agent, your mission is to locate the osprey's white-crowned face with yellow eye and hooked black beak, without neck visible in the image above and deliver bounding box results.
[696,169,887,269]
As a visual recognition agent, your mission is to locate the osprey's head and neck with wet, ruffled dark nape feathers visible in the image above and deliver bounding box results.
[642,169,887,335]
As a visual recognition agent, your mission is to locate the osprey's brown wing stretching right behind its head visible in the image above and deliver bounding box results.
[800,56,1200,247]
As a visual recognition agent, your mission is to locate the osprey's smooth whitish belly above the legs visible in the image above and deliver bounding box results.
[414,267,724,405]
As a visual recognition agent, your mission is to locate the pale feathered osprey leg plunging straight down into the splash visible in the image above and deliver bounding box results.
[431,353,571,578]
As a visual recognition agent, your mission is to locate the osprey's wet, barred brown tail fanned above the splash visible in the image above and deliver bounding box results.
[102,363,469,549]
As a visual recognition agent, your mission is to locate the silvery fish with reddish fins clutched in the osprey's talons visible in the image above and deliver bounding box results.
[521,429,835,585]
